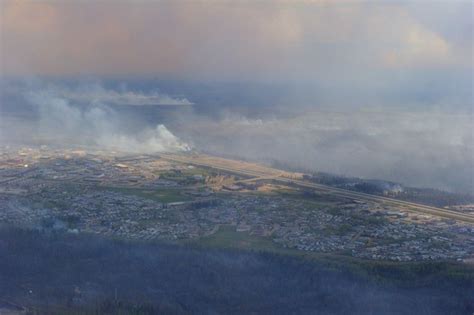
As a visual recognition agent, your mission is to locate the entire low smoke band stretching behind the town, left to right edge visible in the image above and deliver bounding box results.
[0,84,474,193]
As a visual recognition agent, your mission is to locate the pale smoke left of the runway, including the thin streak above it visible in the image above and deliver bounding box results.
[0,86,190,153]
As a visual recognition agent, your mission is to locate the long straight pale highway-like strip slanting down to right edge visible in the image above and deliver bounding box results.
[160,154,474,224]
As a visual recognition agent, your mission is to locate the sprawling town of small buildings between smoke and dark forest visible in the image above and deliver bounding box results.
[0,146,474,262]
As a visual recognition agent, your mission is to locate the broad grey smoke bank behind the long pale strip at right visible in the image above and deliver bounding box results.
[174,110,474,193]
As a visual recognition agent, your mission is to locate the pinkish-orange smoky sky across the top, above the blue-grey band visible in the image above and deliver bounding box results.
[1,0,473,84]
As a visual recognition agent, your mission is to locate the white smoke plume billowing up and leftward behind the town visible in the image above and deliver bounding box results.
[26,89,190,153]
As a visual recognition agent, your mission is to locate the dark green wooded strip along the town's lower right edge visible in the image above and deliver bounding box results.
[185,225,474,286]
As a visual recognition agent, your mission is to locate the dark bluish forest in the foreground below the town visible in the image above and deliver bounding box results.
[0,228,474,315]
